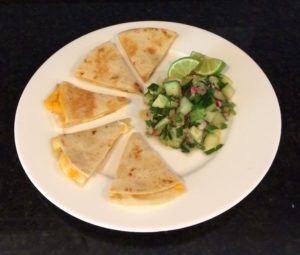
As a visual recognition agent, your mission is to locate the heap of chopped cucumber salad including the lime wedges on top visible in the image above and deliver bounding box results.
[144,51,235,155]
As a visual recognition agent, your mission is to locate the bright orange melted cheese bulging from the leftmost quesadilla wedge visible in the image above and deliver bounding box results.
[44,86,65,121]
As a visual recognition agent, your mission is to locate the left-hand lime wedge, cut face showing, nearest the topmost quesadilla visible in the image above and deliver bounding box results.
[168,57,200,79]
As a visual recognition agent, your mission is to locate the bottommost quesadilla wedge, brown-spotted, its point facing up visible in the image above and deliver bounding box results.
[109,133,185,205]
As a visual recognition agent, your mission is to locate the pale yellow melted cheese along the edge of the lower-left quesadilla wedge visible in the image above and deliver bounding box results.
[52,138,88,185]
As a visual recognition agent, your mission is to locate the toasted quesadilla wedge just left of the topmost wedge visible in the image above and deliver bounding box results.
[75,41,141,93]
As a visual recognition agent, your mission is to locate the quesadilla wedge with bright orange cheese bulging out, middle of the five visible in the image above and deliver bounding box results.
[44,82,128,127]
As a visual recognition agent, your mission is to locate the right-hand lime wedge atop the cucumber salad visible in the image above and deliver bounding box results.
[194,57,226,76]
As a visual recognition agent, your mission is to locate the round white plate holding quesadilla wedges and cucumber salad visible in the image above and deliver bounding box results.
[15,21,281,232]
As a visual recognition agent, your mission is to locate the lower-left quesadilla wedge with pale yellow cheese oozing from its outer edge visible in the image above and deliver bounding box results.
[52,119,130,185]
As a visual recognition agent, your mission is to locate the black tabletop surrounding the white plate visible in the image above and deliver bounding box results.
[0,1,300,255]
